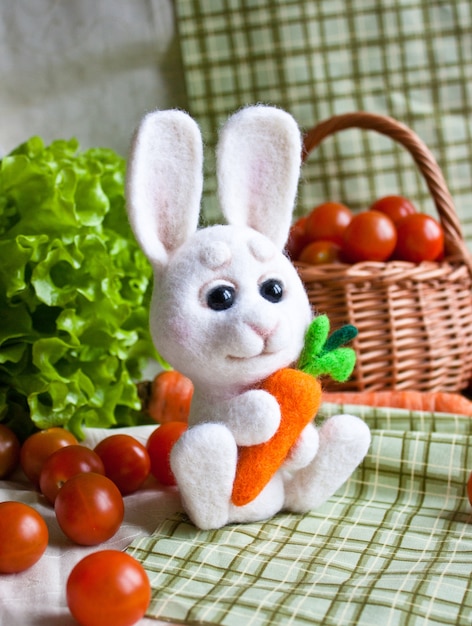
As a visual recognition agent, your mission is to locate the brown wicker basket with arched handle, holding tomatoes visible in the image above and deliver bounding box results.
[296,112,472,391]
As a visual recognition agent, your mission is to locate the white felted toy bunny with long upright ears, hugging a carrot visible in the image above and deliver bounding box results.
[127,106,370,529]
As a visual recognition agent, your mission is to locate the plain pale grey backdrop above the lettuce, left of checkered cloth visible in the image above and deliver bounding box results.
[0,0,185,154]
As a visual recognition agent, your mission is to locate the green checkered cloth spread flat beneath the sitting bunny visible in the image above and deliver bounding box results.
[128,404,472,626]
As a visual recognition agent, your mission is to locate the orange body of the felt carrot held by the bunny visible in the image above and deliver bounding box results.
[231,368,321,506]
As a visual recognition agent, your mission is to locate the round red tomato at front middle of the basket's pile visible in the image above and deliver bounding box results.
[343,211,397,263]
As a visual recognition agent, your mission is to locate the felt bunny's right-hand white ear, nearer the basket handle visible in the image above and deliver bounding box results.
[217,105,302,248]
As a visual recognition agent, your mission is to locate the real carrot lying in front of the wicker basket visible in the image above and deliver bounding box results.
[323,389,472,416]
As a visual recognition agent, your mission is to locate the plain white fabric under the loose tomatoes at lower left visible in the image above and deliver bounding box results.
[0,426,181,626]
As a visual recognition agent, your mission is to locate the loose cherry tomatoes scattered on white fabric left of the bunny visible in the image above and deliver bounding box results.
[0,375,193,626]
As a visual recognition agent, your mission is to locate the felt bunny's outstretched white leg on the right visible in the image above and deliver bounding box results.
[285,415,370,513]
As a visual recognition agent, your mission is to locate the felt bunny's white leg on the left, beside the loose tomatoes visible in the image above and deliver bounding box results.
[171,424,237,530]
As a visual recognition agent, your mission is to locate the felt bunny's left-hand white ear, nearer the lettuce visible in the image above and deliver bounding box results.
[127,110,203,267]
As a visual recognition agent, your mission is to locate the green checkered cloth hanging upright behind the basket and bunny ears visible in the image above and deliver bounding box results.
[176,0,472,246]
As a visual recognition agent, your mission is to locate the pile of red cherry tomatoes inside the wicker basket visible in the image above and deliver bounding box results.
[287,196,444,265]
